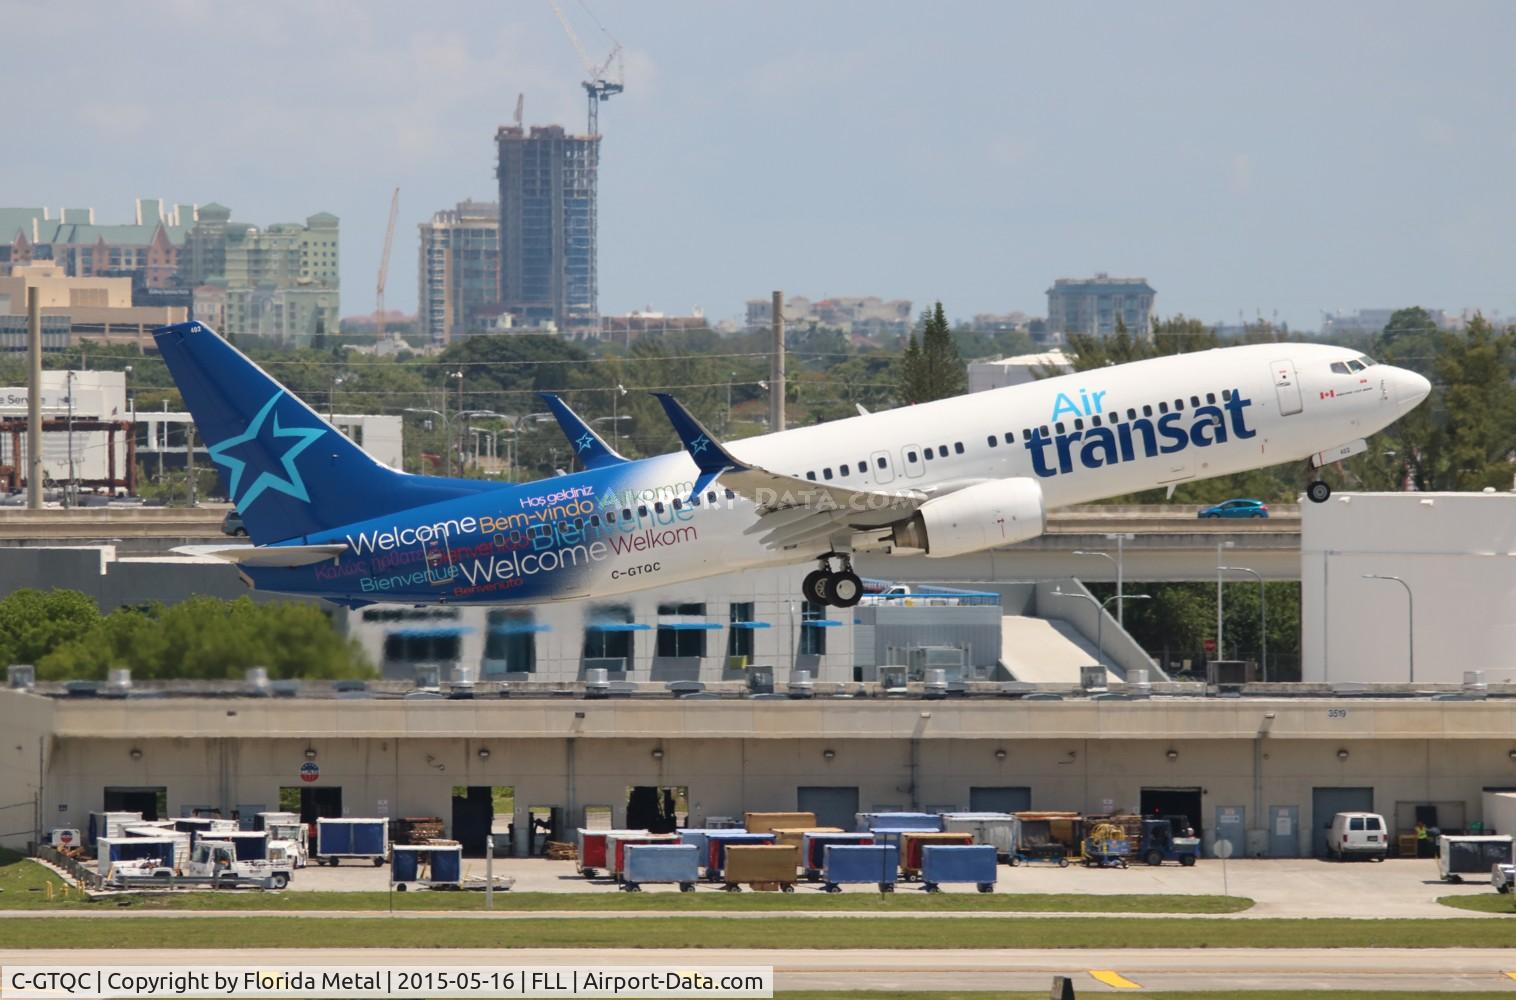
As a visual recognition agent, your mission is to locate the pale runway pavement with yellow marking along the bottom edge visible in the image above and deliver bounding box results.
[0,948,1516,995]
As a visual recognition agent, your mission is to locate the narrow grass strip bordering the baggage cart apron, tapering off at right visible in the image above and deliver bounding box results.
[32,890,1252,914]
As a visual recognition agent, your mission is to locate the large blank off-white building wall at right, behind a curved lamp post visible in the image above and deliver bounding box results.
[1301,492,1516,683]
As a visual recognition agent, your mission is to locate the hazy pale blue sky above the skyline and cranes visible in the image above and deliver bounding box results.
[0,0,1516,329]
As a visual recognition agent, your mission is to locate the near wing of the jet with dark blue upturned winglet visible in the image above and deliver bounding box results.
[653,392,928,548]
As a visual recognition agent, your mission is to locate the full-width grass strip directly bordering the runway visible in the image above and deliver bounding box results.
[0,917,1511,950]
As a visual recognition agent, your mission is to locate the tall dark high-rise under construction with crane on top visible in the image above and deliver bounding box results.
[494,126,600,330]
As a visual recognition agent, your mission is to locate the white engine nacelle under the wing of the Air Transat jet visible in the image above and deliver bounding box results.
[890,477,1048,558]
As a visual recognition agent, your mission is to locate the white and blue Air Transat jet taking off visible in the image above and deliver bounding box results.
[153,323,1431,608]
